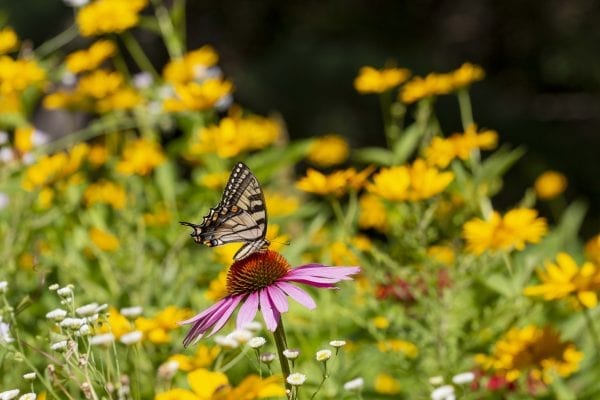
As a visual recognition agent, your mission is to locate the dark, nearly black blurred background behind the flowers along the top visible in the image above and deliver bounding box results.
[0,0,600,239]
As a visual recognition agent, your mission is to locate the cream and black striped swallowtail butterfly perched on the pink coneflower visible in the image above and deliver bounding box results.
[180,162,269,260]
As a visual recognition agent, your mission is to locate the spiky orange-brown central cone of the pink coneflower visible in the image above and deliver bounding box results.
[227,250,291,295]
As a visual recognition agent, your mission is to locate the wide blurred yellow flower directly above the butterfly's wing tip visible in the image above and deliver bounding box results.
[189,116,281,158]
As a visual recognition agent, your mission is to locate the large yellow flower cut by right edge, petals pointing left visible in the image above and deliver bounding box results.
[524,253,600,308]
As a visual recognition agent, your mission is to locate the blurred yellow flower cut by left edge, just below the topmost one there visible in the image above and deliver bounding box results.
[0,56,46,97]
